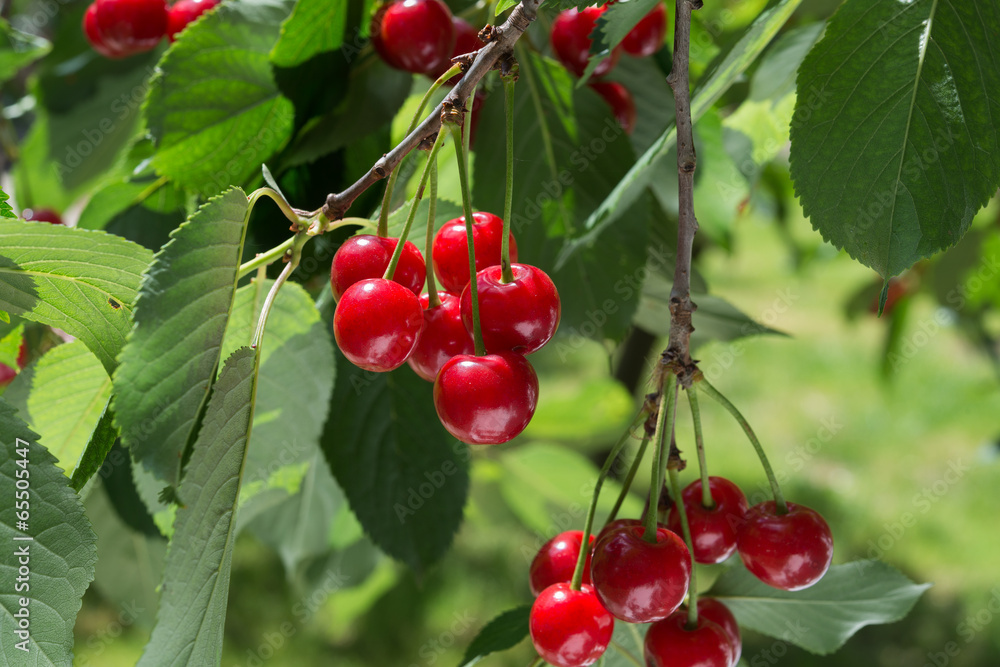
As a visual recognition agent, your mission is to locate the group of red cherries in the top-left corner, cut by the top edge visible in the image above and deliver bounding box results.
[83,0,219,58]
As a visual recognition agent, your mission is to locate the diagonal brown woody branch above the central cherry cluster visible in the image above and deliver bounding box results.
[323,0,542,221]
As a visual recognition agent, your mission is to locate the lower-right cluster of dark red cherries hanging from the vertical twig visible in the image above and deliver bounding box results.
[529,477,833,667]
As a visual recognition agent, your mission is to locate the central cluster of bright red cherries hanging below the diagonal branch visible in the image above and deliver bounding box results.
[330,212,561,445]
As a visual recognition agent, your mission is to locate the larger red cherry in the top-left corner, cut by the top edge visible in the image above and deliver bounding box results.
[94,0,167,57]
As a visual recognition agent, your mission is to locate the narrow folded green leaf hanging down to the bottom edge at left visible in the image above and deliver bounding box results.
[138,347,259,667]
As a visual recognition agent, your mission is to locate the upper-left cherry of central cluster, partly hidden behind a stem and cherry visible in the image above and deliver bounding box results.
[330,234,427,299]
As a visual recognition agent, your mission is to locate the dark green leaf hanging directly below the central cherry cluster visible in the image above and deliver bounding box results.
[322,354,470,572]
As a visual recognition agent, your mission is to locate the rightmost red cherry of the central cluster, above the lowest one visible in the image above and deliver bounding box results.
[462,264,561,354]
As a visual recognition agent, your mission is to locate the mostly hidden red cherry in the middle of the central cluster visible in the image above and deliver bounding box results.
[406,292,476,382]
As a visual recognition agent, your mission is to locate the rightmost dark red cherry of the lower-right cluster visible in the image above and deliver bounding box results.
[736,500,833,591]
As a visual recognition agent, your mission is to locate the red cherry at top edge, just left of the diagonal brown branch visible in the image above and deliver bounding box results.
[371,0,455,74]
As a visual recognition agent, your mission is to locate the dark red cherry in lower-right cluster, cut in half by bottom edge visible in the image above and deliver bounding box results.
[644,611,733,667]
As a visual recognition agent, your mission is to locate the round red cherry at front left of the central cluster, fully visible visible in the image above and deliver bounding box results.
[333,278,424,372]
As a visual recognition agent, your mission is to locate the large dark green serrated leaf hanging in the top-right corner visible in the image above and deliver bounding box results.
[790,0,1000,278]
